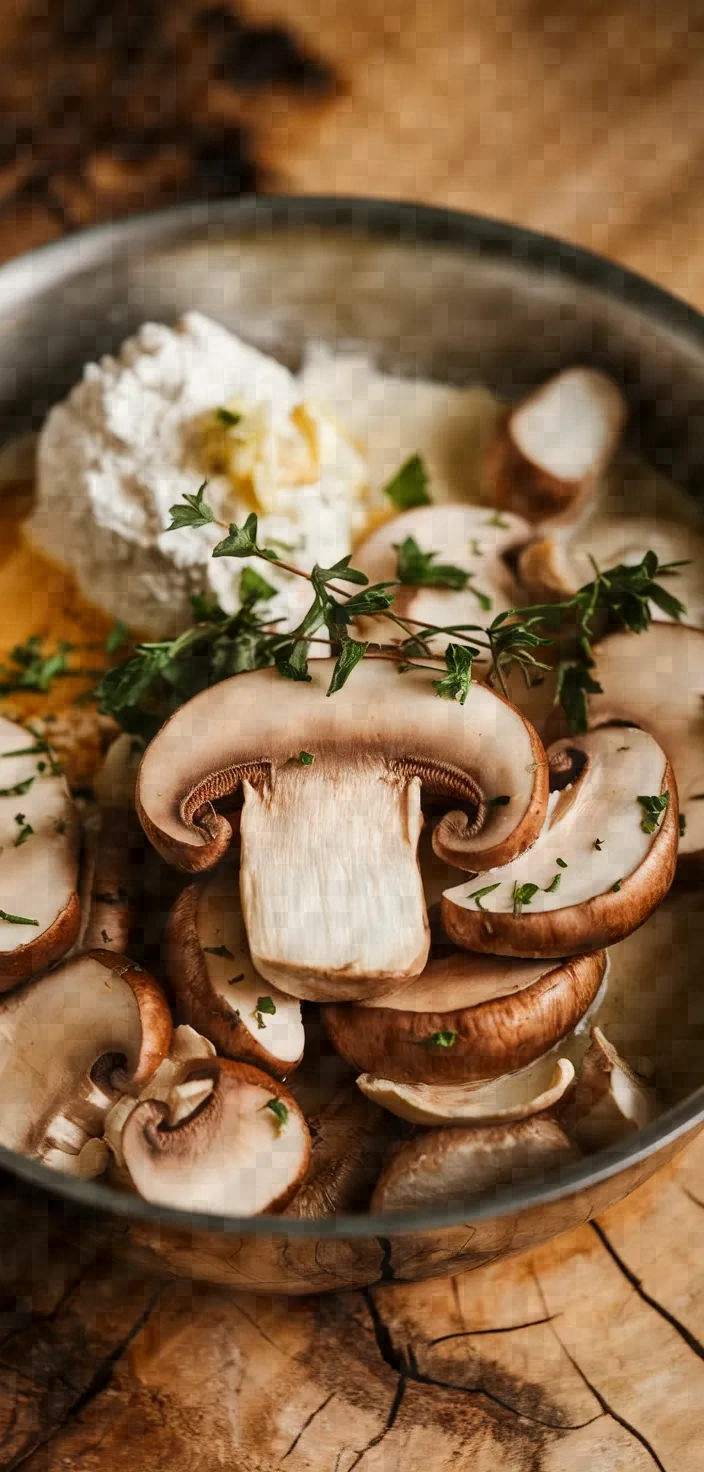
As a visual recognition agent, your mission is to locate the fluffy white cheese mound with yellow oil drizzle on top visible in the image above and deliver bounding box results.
[29,312,367,637]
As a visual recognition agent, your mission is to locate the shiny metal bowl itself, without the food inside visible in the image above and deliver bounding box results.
[0,199,704,1294]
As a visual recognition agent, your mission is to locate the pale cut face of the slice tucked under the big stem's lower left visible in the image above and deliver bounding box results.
[196,864,305,1064]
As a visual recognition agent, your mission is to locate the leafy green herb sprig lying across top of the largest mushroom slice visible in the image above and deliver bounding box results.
[96,479,685,739]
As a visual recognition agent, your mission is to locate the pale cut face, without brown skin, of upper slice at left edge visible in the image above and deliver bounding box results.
[0,718,78,951]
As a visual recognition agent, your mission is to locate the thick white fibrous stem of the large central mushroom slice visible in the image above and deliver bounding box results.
[240,765,429,1001]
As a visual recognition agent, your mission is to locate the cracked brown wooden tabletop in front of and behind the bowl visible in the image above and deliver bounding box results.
[0,0,704,1472]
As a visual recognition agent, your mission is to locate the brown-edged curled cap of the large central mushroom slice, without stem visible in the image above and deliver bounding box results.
[137,659,548,873]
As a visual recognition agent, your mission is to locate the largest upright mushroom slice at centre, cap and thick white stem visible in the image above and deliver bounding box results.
[137,659,548,1001]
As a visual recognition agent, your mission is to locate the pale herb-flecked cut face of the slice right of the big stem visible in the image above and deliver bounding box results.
[445,726,666,914]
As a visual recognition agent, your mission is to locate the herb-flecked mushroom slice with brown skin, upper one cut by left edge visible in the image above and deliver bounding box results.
[0,718,81,992]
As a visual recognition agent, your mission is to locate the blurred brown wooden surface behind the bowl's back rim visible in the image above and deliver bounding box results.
[0,0,704,298]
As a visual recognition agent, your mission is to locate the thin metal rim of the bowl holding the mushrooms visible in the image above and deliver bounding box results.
[0,186,704,1245]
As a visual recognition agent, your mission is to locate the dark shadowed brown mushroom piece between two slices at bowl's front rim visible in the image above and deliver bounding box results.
[284,1083,393,1217]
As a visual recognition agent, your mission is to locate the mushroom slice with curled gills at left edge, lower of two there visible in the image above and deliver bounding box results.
[0,951,171,1173]
